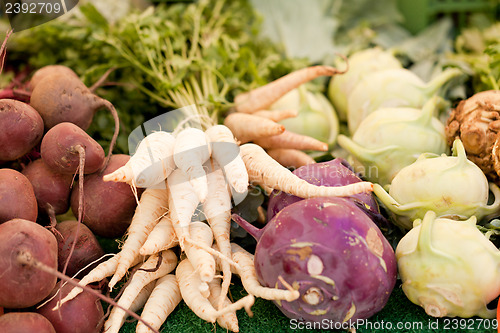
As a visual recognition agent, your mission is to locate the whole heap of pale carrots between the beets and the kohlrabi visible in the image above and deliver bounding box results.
[55,66,372,333]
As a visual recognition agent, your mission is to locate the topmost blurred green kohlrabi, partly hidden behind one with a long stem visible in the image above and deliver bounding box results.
[328,47,403,120]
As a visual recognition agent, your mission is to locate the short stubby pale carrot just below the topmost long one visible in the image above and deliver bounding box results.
[224,112,285,144]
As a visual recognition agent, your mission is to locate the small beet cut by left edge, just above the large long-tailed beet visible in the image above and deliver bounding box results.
[0,168,38,223]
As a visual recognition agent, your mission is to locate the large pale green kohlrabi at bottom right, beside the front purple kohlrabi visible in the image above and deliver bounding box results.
[396,211,500,318]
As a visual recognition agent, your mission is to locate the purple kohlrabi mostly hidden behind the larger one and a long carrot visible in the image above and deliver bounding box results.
[267,158,380,224]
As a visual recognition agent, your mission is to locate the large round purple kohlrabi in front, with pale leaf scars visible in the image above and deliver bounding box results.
[255,197,397,323]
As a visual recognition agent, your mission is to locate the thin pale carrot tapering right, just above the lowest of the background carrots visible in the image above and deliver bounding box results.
[253,130,328,151]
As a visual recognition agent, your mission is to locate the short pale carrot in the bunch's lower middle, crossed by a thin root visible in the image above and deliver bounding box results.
[184,221,215,282]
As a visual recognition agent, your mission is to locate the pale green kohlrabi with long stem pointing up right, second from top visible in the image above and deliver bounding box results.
[347,68,462,134]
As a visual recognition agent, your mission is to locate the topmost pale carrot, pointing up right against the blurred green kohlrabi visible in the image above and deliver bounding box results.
[234,66,345,113]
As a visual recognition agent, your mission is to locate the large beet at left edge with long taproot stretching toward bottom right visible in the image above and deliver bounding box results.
[0,219,57,308]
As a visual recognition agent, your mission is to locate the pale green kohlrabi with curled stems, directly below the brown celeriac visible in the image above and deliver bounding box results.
[374,139,500,229]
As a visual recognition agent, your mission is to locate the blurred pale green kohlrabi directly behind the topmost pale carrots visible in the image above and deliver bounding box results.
[270,86,339,147]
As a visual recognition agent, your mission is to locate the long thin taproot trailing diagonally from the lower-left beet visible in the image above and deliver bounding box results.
[17,251,159,333]
